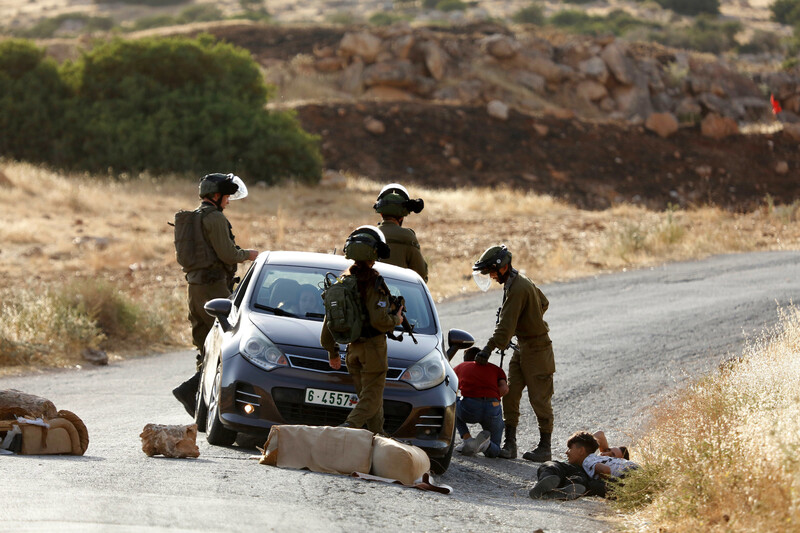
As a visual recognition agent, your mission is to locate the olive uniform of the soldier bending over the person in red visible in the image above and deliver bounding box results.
[484,269,556,433]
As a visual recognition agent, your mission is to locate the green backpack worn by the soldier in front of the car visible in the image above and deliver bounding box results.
[322,272,366,344]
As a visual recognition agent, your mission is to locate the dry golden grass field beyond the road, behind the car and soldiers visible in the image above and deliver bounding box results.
[0,159,800,374]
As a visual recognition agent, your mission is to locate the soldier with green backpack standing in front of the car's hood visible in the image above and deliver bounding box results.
[320,226,403,433]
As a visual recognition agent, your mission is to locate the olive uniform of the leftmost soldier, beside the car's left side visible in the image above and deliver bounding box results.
[186,202,250,364]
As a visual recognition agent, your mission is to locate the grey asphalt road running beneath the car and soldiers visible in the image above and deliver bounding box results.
[0,252,800,533]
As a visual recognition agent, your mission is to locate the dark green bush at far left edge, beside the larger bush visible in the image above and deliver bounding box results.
[0,39,69,162]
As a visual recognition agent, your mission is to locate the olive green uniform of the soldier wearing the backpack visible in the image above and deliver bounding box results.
[320,274,401,433]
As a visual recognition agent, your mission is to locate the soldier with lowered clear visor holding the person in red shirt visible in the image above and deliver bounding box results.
[472,244,556,462]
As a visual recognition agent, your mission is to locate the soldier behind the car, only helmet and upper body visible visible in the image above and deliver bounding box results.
[372,183,428,283]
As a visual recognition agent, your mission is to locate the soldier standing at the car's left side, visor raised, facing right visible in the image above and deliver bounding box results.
[172,174,258,416]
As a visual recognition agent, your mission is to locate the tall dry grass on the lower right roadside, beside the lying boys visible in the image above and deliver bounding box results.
[616,307,800,533]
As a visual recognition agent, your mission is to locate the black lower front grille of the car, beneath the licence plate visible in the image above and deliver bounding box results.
[272,387,411,435]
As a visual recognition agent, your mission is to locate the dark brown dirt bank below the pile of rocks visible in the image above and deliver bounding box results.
[297,102,800,210]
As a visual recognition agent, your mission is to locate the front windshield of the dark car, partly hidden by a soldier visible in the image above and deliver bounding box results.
[253,265,436,335]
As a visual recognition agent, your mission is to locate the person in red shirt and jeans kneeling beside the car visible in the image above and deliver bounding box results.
[453,348,508,457]
